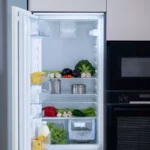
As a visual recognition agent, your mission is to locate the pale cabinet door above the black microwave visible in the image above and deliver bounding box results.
[107,0,150,41]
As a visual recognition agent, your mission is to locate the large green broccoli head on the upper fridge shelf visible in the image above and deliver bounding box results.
[75,60,95,75]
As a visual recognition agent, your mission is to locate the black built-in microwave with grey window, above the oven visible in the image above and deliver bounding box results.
[106,41,150,91]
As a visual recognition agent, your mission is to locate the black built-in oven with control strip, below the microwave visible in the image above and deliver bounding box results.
[106,92,150,150]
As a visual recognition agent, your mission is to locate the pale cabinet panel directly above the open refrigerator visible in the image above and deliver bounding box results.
[28,0,106,12]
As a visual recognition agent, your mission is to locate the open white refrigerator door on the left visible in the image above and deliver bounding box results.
[12,7,42,150]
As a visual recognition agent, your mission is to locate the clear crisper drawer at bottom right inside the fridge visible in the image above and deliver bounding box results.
[68,119,96,143]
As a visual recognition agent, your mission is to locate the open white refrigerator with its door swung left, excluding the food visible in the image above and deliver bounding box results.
[12,6,105,150]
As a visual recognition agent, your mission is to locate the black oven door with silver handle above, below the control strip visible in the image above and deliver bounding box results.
[107,105,150,150]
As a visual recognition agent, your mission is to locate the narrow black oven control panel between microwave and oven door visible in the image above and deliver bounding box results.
[106,92,150,104]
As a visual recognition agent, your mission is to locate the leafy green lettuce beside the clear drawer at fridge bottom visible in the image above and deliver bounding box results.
[47,123,67,144]
